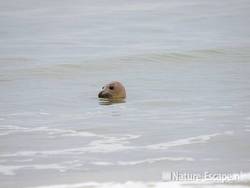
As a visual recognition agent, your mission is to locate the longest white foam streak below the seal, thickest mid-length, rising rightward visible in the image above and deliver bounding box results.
[0,131,233,157]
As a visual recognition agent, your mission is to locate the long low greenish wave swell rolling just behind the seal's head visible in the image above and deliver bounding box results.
[4,47,250,79]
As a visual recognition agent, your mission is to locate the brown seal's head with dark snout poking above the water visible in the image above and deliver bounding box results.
[98,81,126,99]
